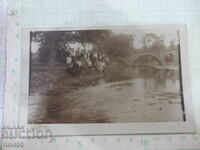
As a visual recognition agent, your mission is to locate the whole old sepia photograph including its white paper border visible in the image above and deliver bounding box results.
[19,25,196,136]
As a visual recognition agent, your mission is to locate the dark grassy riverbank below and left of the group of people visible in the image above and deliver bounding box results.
[30,66,104,94]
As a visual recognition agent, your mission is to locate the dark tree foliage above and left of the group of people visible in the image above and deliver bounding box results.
[32,30,110,64]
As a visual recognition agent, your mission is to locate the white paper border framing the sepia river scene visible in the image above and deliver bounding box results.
[19,24,196,136]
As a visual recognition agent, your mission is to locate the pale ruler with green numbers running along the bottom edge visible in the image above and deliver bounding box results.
[3,134,200,150]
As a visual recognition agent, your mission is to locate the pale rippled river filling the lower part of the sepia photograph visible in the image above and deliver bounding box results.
[29,67,183,123]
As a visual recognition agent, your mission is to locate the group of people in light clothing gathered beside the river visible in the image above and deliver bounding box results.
[66,49,109,77]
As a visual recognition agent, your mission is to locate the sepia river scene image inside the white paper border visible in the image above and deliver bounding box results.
[28,26,185,124]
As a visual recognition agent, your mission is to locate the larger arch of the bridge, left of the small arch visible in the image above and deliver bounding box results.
[132,54,162,66]
